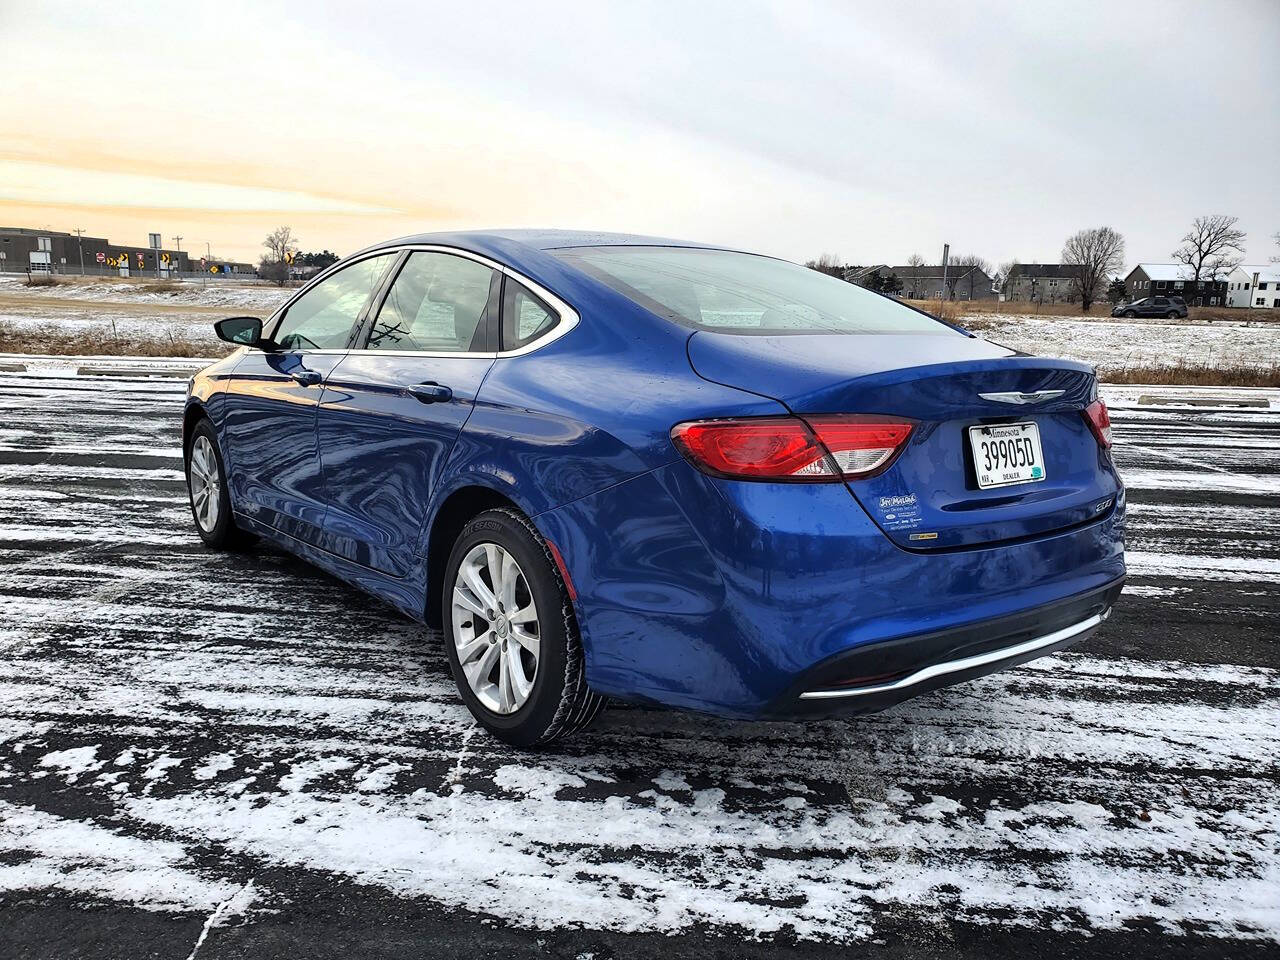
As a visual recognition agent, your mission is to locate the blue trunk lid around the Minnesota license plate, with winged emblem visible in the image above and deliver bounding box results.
[689,332,1120,550]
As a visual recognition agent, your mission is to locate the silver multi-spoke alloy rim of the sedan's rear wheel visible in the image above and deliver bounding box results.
[452,543,541,714]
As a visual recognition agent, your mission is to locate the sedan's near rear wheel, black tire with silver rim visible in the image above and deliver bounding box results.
[440,508,605,748]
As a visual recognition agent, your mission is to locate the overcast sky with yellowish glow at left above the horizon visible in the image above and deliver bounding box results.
[0,0,1280,264]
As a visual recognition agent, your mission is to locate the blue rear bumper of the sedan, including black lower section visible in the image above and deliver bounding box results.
[535,462,1125,718]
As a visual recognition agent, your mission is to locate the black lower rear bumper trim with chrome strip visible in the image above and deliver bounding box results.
[764,581,1124,717]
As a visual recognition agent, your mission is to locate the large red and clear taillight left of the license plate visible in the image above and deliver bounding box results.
[671,415,914,481]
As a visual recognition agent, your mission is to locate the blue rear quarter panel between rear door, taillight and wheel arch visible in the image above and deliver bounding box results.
[439,288,782,527]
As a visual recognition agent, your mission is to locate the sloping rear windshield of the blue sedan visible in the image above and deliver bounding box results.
[549,247,948,334]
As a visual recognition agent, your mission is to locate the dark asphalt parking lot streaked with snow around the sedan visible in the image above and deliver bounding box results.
[0,372,1280,959]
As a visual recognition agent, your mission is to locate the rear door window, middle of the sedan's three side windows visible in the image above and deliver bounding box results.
[367,251,493,353]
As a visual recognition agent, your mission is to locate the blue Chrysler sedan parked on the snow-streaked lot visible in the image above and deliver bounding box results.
[183,232,1125,746]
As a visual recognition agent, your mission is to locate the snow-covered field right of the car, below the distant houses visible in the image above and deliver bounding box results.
[961,314,1280,370]
